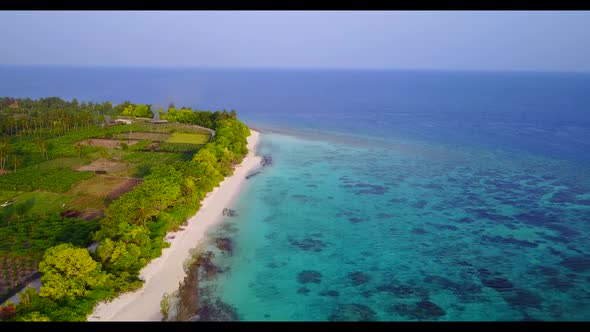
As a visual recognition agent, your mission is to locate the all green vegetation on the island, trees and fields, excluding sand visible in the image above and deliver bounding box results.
[0,98,250,321]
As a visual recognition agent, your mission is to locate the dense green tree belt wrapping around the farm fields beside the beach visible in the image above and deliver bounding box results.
[0,98,250,321]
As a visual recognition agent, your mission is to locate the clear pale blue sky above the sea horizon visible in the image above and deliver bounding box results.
[0,11,590,71]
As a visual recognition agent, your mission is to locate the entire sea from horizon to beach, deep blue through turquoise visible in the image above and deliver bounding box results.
[0,67,590,321]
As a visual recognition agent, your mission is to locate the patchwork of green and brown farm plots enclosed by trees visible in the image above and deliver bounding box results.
[0,124,209,300]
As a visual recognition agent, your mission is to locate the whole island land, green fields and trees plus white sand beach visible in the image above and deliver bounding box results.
[0,97,260,321]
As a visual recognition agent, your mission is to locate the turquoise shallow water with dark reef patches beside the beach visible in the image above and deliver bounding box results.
[195,133,590,321]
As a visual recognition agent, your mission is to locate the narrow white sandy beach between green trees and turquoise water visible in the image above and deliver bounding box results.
[88,130,261,321]
